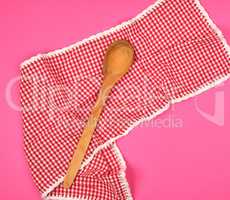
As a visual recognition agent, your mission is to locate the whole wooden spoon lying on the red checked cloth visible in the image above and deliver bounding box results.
[64,40,134,188]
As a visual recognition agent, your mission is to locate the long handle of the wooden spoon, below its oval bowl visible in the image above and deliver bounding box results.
[64,76,117,188]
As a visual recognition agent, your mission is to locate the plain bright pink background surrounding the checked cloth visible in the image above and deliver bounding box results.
[0,0,230,200]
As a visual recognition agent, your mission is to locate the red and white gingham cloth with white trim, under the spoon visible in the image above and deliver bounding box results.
[20,0,230,200]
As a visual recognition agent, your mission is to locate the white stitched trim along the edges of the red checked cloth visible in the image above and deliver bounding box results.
[35,0,230,200]
